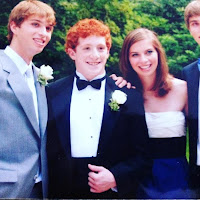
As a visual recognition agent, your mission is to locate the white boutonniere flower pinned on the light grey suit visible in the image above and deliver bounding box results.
[38,65,53,86]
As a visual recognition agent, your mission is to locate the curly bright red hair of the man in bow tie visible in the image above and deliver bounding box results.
[65,18,112,53]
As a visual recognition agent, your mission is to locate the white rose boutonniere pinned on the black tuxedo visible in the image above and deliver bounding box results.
[108,90,127,111]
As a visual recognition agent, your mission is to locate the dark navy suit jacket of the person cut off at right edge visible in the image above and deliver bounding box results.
[182,61,200,187]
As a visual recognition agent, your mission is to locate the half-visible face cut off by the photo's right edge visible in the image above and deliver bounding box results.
[189,15,200,45]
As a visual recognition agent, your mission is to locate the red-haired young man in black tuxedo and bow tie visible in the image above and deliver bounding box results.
[46,19,151,199]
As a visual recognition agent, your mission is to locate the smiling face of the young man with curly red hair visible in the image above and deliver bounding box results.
[68,36,109,80]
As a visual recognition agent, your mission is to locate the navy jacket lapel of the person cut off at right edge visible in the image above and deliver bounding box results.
[187,64,199,119]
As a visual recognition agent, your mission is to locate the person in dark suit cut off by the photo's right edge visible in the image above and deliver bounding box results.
[183,0,200,198]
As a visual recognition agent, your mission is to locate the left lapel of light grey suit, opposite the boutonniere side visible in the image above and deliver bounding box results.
[2,55,40,135]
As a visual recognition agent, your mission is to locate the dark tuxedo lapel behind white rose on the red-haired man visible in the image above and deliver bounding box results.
[98,77,120,154]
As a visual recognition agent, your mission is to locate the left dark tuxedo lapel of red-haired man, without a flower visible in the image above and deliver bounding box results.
[52,76,74,157]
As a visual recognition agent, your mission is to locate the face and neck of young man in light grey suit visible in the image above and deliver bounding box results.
[10,15,53,64]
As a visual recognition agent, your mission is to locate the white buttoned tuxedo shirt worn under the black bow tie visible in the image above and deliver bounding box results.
[70,72,106,157]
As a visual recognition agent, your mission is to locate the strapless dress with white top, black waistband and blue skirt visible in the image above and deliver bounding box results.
[138,111,191,199]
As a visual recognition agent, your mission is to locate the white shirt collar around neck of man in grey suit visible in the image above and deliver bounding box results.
[4,46,32,75]
